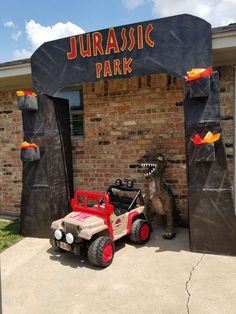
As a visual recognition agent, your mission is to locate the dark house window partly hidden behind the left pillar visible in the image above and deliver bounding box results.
[54,86,84,137]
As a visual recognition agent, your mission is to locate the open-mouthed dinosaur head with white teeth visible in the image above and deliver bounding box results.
[137,151,167,178]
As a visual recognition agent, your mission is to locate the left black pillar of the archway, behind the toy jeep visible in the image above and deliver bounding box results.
[21,95,73,237]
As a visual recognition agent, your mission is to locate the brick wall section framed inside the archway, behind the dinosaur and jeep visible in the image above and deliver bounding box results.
[73,75,187,218]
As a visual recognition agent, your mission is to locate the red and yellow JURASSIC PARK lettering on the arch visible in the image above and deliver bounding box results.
[67,23,155,79]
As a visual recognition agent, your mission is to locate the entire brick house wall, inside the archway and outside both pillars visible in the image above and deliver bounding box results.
[0,66,234,215]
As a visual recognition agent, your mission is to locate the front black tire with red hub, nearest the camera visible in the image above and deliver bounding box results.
[88,237,115,267]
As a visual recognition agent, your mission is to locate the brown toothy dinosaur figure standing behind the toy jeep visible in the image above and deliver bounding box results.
[138,150,175,239]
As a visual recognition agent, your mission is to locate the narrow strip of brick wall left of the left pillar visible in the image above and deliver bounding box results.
[0,91,22,213]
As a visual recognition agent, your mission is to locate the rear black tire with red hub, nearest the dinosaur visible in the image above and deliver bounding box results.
[129,219,151,244]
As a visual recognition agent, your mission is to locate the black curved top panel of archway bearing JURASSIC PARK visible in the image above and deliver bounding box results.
[31,14,211,95]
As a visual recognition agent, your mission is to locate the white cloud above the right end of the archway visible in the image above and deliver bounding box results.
[123,0,236,27]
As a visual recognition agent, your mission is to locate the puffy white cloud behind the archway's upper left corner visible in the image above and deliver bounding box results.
[12,20,84,59]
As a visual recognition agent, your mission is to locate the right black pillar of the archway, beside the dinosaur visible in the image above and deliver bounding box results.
[184,72,236,255]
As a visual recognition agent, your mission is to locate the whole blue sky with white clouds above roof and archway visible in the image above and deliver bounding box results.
[0,0,236,63]
